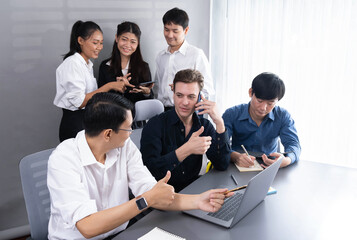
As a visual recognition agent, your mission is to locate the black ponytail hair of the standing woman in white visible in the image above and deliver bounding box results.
[63,20,103,60]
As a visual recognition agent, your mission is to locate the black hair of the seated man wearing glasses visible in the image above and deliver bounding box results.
[83,92,133,137]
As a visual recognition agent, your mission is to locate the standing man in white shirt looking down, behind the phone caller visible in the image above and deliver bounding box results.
[153,8,215,110]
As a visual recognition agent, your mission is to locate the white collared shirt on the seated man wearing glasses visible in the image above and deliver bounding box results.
[47,131,156,239]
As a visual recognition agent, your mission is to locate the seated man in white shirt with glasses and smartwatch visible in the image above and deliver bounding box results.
[47,93,232,239]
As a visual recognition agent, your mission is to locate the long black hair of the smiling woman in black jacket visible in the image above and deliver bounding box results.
[105,22,147,85]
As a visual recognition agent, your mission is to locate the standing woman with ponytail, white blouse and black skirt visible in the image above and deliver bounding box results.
[53,21,134,142]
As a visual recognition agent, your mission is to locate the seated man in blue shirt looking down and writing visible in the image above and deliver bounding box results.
[223,73,301,167]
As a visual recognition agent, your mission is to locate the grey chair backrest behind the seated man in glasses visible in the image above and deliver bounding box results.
[19,148,54,240]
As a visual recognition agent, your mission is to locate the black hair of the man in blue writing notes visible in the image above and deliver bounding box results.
[252,72,285,101]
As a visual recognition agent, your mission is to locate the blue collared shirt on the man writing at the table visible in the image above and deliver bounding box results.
[223,103,301,163]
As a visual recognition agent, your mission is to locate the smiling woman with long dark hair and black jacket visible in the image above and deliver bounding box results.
[98,22,153,103]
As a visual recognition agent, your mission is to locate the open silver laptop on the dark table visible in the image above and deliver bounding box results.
[183,157,283,228]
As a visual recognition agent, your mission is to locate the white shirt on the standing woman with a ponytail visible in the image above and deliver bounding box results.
[53,53,98,111]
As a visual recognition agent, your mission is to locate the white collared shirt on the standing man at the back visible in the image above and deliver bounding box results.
[153,40,215,107]
